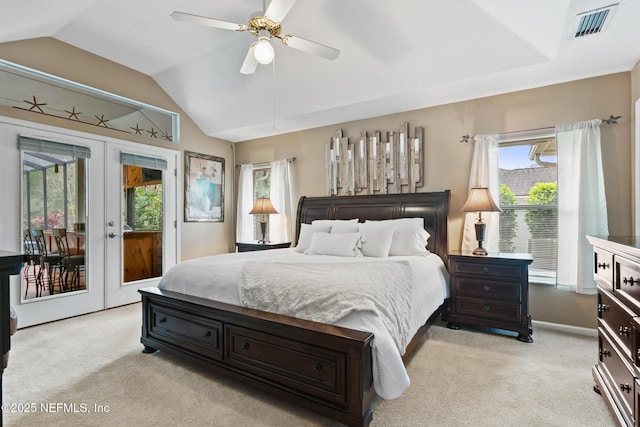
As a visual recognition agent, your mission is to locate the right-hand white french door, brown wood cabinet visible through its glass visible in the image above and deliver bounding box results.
[105,143,178,308]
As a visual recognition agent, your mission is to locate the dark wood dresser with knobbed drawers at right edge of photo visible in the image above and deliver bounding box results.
[587,236,640,426]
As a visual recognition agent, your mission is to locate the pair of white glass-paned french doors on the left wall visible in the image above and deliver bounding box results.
[0,118,180,327]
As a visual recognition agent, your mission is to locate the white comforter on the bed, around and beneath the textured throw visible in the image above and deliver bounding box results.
[159,249,449,399]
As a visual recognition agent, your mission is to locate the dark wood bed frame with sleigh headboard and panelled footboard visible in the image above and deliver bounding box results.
[140,190,450,426]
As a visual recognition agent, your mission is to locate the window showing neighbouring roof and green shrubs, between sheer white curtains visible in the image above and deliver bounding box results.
[498,135,558,284]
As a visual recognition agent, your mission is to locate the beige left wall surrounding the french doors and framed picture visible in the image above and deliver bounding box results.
[0,38,233,260]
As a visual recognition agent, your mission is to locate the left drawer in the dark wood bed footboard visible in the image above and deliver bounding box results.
[149,305,222,359]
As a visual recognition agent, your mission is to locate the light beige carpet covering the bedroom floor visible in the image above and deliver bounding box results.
[3,304,614,427]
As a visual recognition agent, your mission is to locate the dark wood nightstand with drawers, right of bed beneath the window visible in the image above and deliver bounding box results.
[447,251,533,342]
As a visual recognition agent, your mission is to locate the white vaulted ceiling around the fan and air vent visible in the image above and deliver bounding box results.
[0,0,640,142]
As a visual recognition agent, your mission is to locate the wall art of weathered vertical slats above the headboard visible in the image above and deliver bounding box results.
[326,122,424,196]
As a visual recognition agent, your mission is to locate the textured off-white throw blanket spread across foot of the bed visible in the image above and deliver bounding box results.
[238,261,412,352]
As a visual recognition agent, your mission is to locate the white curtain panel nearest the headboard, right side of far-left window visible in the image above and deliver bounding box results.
[269,159,291,242]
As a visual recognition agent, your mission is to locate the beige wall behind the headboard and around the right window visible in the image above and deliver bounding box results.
[235,73,631,327]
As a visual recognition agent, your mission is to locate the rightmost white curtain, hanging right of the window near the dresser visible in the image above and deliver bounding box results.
[556,119,609,294]
